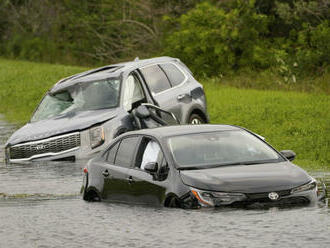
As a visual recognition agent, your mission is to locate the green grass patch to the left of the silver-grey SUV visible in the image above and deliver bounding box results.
[0,58,86,125]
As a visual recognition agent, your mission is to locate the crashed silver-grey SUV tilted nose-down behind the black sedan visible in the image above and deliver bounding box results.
[6,57,209,162]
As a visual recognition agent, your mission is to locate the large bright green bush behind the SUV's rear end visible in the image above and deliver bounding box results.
[166,1,271,76]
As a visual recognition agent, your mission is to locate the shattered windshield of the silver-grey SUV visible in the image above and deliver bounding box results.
[31,78,120,122]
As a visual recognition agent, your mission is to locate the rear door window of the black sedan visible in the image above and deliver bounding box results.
[115,136,140,168]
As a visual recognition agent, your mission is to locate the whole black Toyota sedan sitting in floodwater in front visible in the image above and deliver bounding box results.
[82,125,317,208]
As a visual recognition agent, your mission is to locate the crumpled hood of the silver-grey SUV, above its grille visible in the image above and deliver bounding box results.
[6,109,118,146]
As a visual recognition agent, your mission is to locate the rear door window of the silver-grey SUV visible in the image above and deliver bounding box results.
[140,65,171,94]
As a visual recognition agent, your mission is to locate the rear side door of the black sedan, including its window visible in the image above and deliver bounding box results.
[102,136,140,202]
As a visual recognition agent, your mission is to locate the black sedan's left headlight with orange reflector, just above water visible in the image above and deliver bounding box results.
[190,188,246,207]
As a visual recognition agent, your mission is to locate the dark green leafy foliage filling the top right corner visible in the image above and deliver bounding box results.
[274,0,330,76]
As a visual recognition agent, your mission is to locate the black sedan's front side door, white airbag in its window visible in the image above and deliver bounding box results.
[124,137,168,205]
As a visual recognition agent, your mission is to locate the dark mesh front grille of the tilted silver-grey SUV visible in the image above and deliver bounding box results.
[9,132,80,159]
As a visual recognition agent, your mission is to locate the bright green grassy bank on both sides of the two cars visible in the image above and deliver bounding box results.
[0,59,330,169]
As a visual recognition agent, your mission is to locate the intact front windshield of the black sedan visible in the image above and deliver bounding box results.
[168,131,284,169]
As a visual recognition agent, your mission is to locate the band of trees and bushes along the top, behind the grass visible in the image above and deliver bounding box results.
[0,0,330,78]
